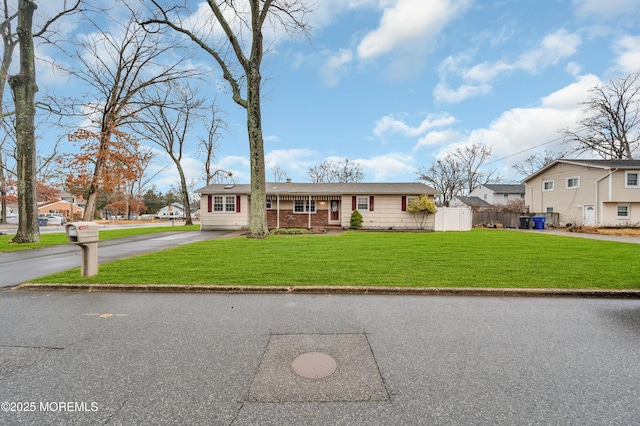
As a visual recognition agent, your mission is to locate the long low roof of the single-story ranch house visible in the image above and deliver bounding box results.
[195,182,436,195]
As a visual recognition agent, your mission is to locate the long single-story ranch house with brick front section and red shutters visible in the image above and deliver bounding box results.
[196,182,444,231]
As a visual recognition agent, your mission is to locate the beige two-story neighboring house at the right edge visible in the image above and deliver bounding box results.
[522,159,640,226]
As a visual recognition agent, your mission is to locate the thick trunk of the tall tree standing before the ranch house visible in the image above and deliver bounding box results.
[247,61,269,238]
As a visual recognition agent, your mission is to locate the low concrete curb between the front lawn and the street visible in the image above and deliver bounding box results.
[12,283,640,299]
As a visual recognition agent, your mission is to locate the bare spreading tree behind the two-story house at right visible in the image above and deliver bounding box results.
[561,72,640,160]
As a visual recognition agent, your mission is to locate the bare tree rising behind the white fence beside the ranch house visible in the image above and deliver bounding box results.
[418,155,466,207]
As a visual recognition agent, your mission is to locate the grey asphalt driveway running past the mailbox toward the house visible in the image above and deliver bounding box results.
[0,231,228,287]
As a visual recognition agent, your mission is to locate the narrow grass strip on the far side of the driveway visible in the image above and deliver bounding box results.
[0,225,200,253]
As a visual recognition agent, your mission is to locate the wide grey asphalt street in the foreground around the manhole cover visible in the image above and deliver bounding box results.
[0,292,640,425]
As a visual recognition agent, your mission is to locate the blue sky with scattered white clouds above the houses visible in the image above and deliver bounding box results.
[22,0,640,193]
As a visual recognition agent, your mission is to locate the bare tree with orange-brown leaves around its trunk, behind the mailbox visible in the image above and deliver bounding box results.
[59,16,196,220]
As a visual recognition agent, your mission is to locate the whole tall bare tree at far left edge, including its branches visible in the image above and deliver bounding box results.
[0,0,81,243]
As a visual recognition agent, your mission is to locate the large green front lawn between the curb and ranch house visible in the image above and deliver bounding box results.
[34,230,640,289]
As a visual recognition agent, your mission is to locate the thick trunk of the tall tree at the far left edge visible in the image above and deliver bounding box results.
[9,0,40,243]
